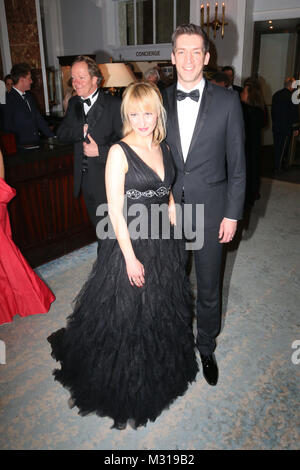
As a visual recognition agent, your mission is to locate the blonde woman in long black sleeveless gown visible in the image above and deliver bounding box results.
[48,82,198,429]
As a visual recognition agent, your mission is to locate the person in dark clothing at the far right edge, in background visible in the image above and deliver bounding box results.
[271,77,299,174]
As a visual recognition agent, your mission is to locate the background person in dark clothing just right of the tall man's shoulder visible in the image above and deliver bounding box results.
[240,77,265,209]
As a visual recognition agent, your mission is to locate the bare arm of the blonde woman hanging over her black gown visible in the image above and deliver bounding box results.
[105,145,145,286]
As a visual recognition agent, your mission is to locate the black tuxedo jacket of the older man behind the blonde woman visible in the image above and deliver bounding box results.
[57,90,122,204]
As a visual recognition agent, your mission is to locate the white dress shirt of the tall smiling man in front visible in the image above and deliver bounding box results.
[177,78,205,161]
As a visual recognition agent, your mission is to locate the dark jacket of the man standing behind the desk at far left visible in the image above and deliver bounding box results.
[4,88,54,145]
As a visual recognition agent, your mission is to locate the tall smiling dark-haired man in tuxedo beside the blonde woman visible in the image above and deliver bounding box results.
[164,24,245,385]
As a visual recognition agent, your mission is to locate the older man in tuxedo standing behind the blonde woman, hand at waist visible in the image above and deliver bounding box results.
[57,56,122,232]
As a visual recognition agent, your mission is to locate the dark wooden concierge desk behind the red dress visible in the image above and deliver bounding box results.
[4,144,96,267]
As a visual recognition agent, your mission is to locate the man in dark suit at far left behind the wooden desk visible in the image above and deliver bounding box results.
[4,63,54,146]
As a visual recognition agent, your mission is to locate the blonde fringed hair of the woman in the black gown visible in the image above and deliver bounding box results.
[121,82,166,144]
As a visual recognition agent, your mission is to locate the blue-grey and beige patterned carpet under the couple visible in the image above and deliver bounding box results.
[0,179,300,450]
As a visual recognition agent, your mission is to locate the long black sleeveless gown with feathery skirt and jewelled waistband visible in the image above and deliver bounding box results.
[48,142,198,429]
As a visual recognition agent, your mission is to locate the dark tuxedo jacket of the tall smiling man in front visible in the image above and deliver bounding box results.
[163,80,246,228]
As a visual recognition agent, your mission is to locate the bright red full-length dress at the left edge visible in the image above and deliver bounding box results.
[0,178,55,324]
